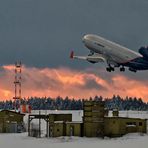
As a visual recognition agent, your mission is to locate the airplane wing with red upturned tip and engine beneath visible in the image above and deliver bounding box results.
[70,51,106,63]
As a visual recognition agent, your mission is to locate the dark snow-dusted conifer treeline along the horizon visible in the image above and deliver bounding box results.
[0,95,148,110]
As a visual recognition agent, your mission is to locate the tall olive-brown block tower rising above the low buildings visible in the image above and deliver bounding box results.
[83,101,105,137]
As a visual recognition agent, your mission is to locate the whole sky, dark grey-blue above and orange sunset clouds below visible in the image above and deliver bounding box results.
[0,0,148,101]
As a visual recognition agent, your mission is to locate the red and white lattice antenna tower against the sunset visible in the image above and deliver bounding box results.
[13,62,22,111]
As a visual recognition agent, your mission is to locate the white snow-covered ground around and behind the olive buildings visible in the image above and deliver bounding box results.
[0,111,148,148]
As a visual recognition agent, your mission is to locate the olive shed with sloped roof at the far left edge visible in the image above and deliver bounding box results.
[0,110,24,133]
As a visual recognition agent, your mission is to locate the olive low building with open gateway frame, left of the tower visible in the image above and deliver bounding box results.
[28,114,72,137]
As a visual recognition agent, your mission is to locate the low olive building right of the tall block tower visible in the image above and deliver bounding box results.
[104,117,146,137]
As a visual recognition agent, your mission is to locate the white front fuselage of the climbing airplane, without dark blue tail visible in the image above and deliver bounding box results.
[83,34,142,63]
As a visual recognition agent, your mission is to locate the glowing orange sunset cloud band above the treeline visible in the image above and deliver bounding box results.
[0,65,148,101]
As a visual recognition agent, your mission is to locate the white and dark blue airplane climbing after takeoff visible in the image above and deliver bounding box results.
[70,34,148,72]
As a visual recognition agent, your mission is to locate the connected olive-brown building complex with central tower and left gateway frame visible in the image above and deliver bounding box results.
[28,101,146,138]
